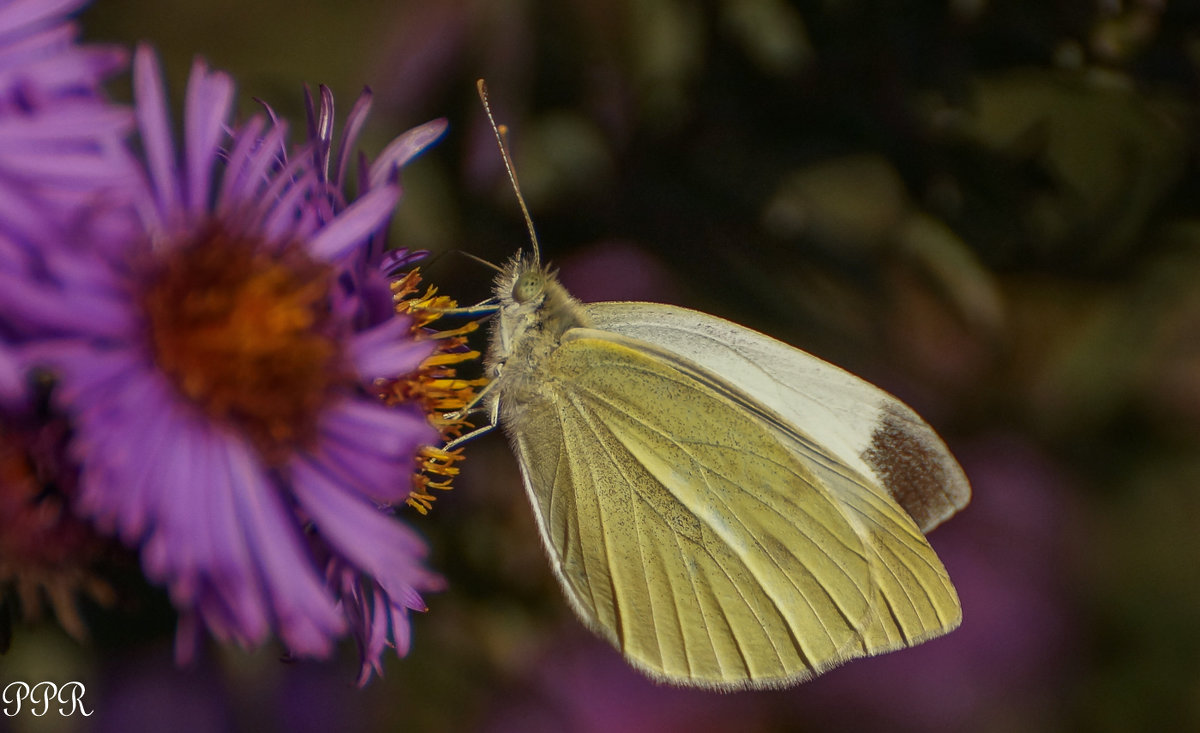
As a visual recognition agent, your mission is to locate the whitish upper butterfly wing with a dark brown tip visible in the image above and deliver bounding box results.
[584,302,971,531]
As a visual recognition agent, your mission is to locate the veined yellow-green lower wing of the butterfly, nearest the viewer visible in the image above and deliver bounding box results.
[502,330,960,687]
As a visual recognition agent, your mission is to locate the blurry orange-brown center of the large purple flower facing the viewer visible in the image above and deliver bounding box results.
[144,226,348,461]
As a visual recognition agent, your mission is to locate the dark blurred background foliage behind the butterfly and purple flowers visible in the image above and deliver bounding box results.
[0,0,1200,733]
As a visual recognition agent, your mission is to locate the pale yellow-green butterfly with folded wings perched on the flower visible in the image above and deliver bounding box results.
[448,82,971,690]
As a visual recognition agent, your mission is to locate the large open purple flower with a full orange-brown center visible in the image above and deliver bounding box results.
[0,48,444,669]
